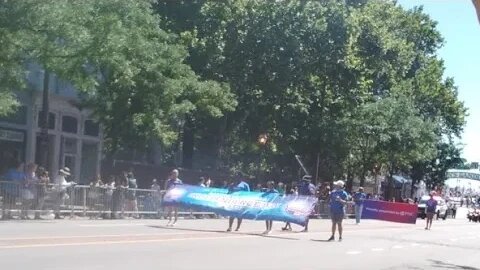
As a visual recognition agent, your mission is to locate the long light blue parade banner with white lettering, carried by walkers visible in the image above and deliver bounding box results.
[163,185,317,226]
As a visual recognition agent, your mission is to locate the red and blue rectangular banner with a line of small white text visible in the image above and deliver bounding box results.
[362,200,417,224]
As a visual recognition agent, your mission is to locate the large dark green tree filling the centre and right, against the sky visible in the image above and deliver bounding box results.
[157,0,465,184]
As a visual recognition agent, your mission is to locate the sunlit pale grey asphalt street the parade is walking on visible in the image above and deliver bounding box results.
[0,208,480,270]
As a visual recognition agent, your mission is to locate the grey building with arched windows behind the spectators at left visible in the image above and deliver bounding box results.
[0,65,102,183]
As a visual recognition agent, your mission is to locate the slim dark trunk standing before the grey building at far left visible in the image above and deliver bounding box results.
[37,70,50,169]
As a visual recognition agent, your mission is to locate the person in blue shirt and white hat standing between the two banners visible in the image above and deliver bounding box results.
[328,180,348,241]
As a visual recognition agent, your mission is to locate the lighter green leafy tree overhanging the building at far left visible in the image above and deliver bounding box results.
[0,0,235,167]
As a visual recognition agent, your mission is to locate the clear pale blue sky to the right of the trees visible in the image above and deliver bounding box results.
[397,0,480,162]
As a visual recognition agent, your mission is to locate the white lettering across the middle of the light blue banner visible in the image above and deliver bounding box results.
[187,193,281,209]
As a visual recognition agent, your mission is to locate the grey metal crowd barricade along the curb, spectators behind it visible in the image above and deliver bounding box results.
[0,181,217,219]
